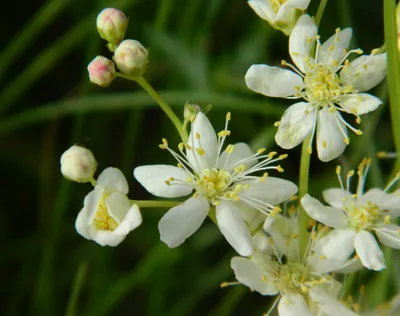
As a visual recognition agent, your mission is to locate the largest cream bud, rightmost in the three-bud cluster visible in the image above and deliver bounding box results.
[114,40,149,76]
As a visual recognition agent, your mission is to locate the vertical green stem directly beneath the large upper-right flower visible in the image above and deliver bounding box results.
[298,135,311,258]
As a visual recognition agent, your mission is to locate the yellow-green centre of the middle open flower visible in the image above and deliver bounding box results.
[197,168,231,199]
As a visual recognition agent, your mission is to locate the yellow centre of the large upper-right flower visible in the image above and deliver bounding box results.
[304,63,344,106]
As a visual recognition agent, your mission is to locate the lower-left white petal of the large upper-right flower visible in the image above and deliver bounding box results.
[275,102,315,149]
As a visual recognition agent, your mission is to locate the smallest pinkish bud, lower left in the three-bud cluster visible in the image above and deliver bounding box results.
[88,56,116,88]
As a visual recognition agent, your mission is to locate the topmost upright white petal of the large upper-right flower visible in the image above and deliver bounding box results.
[289,14,318,73]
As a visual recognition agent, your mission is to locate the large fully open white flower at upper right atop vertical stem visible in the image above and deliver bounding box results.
[245,15,386,161]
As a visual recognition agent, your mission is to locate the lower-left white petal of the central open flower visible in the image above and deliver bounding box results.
[158,197,210,248]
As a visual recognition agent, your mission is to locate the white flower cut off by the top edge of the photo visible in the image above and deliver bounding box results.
[248,0,310,35]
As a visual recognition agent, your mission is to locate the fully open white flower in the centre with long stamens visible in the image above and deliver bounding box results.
[134,113,297,256]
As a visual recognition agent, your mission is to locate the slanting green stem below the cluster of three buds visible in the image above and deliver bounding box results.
[117,73,188,143]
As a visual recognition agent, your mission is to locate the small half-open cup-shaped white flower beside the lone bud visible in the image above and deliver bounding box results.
[75,167,142,246]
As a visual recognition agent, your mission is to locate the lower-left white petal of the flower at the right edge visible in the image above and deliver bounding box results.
[309,228,356,273]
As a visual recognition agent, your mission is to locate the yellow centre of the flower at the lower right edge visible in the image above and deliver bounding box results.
[346,202,380,230]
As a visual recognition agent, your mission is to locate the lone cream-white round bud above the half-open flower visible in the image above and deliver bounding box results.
[60,146,97,183]
